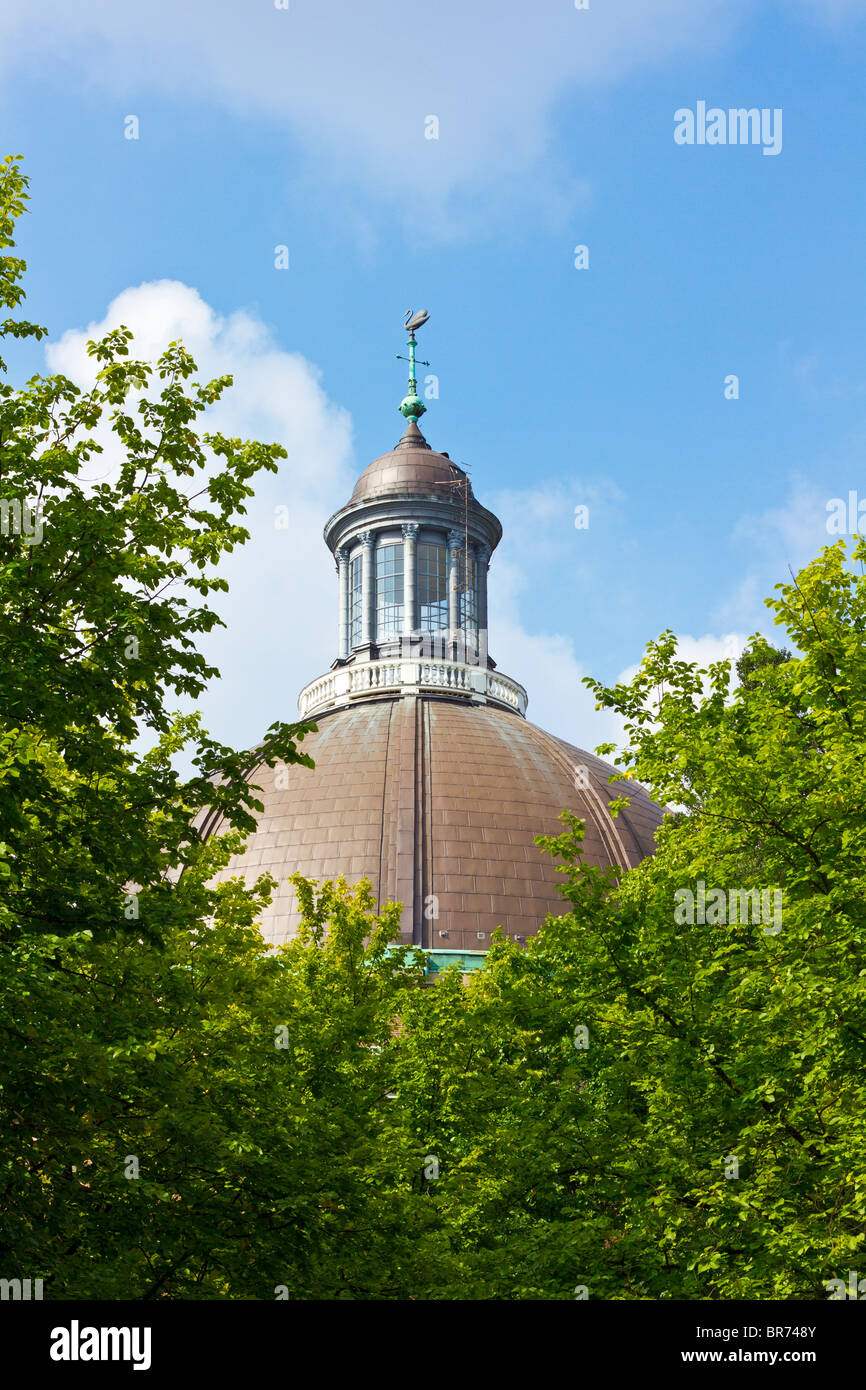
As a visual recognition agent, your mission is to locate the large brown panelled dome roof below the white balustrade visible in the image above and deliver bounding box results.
[206,695,662,951]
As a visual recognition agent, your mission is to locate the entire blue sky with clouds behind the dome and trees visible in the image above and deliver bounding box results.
[0,0,866,746]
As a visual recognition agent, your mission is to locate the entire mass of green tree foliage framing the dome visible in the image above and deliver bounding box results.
[0,161,866,1300]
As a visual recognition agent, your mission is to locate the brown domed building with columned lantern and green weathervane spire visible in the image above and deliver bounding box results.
[203,319,662,973]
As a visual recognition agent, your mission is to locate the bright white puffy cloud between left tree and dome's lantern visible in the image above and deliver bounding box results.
[46,281,354,746]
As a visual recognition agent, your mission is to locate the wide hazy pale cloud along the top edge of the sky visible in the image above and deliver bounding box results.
[0,0,752,231]
